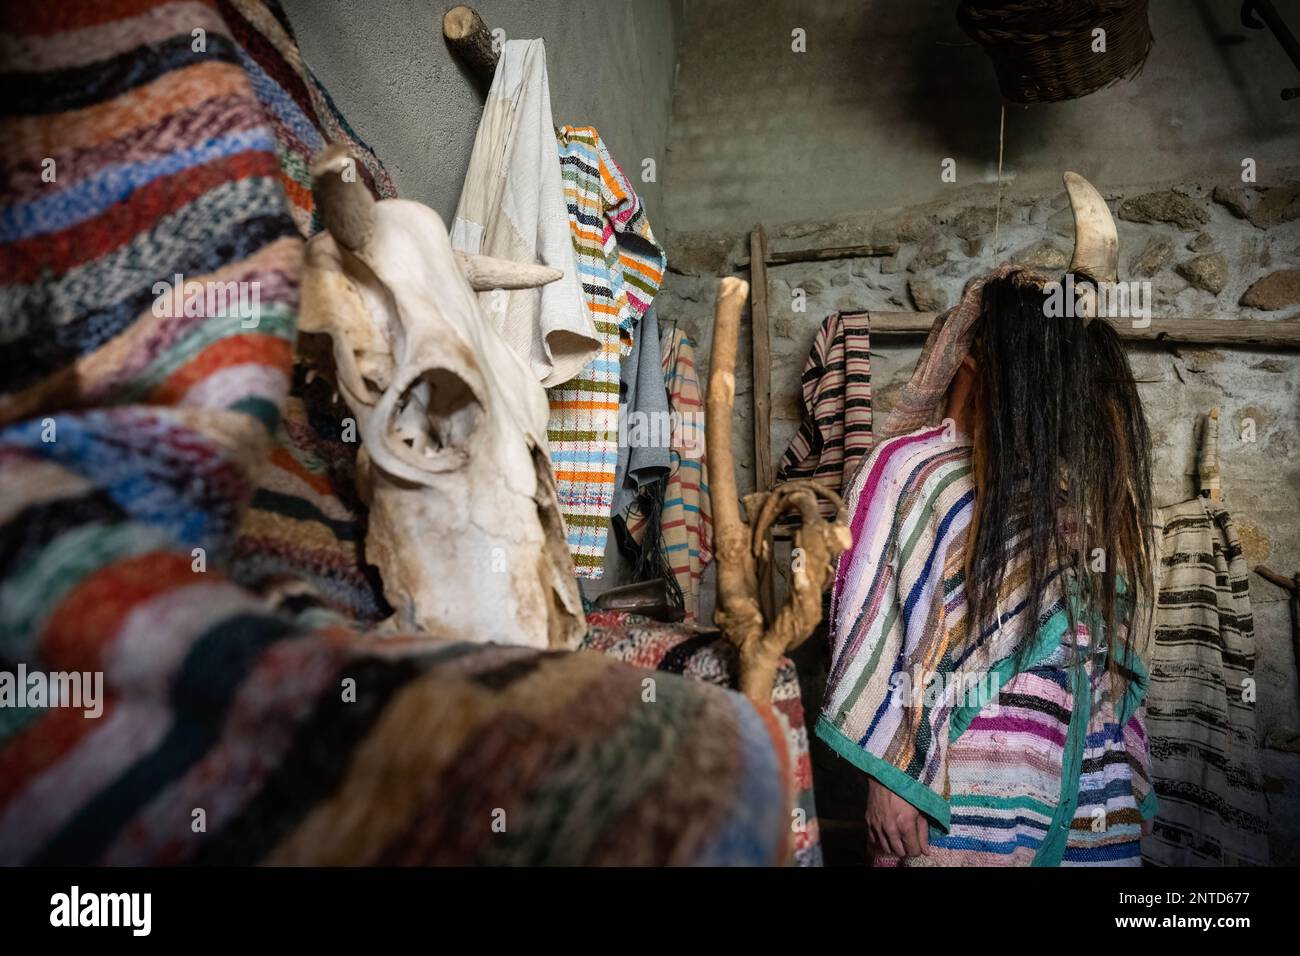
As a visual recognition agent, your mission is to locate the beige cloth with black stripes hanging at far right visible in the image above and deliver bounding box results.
[1143,498,1269,866]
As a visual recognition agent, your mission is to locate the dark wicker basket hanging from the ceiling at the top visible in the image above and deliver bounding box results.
[957,0,1152,103]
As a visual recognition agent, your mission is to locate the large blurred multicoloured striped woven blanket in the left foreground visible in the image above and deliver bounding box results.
[0,0,792,865]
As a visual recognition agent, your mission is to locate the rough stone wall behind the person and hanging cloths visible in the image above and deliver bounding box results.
[659,168,1300,861]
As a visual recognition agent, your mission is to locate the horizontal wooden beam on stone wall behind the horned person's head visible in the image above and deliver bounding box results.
[871,310,1300,349]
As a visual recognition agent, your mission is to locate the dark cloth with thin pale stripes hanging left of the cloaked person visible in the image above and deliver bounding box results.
[776,312,871,492]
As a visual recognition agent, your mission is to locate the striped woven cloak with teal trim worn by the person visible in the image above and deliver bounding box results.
[818,425,1154,866]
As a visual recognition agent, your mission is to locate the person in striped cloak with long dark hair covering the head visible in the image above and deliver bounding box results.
[818,179,1156,866]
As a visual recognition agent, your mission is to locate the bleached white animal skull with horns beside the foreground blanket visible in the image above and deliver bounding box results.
[299,144,585,648]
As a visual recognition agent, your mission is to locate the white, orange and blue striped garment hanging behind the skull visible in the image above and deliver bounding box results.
[547,126,667,579]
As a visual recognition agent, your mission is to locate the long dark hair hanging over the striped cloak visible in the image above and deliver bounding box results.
[966,273,1152,663]
